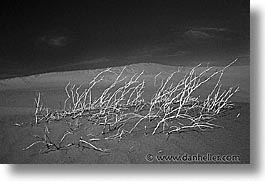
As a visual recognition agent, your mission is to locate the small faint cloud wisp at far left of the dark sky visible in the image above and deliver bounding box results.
[40,36,68,47]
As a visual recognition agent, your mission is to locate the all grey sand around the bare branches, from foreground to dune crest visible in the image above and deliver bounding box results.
[0,63,250,163]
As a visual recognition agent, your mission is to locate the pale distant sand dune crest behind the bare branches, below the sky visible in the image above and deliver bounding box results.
[0,63,250,102]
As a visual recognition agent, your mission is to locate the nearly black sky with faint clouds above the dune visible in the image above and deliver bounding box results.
[0,0,249,77]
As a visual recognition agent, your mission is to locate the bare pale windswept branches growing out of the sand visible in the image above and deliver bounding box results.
[24,59,239,153]
